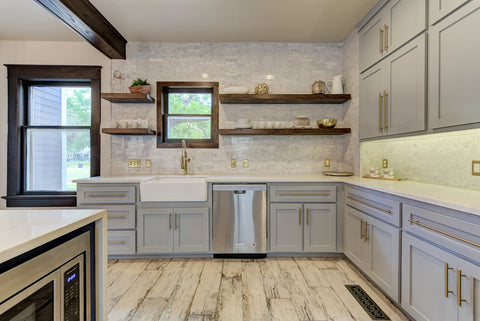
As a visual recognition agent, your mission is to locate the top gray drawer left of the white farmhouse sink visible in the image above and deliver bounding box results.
[77,185,135,204]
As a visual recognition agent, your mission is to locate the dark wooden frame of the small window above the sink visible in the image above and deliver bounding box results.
[157,81,219,148]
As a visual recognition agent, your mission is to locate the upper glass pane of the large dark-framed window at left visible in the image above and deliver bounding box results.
[28,86,91,126]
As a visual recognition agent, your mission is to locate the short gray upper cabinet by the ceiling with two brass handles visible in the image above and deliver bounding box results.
[360,0,426,72]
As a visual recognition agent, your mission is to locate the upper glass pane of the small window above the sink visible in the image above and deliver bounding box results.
[168,93,212,115]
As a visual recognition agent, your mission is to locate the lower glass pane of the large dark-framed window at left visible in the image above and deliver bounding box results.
[25,129,90,192]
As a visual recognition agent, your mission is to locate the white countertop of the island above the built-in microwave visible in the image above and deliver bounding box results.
[0,209,107,263]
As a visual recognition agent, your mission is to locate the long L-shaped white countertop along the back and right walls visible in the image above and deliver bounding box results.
[75,174,480,215]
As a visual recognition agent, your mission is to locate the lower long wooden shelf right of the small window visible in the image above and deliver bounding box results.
[219,128,351,136]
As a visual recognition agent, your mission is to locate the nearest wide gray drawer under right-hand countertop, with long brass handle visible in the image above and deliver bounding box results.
[403,204,480,262]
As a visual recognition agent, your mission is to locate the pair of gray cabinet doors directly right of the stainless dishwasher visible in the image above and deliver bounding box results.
[270,203,337,253]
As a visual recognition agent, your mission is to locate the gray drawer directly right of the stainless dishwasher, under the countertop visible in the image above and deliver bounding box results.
[270,184,337,203]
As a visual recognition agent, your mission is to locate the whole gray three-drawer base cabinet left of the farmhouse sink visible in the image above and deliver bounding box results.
[77,183,137,255]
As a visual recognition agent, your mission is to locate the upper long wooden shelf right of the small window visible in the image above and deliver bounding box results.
[220,94,351,104]
